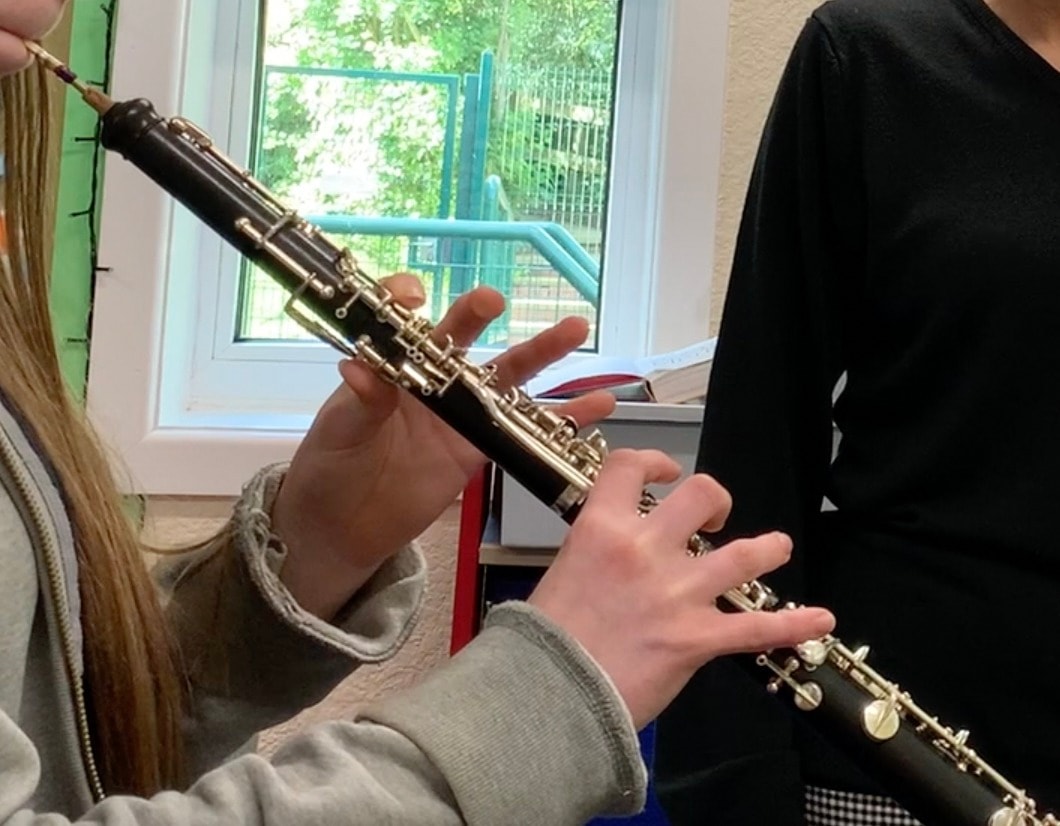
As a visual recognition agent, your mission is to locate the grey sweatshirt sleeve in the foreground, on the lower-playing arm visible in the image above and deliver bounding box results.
[0,603,647,826]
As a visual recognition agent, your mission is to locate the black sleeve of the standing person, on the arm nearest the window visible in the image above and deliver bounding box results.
[656,18,864,826]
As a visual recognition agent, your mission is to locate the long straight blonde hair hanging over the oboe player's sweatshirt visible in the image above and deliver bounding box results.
[0,63,183,795]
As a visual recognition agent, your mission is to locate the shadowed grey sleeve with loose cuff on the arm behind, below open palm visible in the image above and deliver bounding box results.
[158,465,426,777]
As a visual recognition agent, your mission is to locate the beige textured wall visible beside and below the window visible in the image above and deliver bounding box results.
[140,0,817,741]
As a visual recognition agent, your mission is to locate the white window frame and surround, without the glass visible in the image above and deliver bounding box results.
[88,0,728,496]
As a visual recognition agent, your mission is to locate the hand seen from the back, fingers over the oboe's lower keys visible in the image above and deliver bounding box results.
[528,450,835,730]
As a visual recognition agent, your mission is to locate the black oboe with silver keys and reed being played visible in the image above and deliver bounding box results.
[29,43,1060,826]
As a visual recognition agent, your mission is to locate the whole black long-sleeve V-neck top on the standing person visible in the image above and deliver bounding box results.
[656,0,1060,826]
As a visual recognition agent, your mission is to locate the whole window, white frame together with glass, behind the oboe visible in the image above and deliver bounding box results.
[89,0,727,494]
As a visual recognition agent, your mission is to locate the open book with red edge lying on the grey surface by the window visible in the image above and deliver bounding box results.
[526,338,718,404]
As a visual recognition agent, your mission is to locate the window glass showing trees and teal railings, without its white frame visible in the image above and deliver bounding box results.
[236,0,619,347]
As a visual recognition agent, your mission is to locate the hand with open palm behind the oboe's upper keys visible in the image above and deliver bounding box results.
[272,275,615,618]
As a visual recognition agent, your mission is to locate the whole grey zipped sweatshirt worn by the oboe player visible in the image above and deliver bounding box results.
[0,399,646,826]
